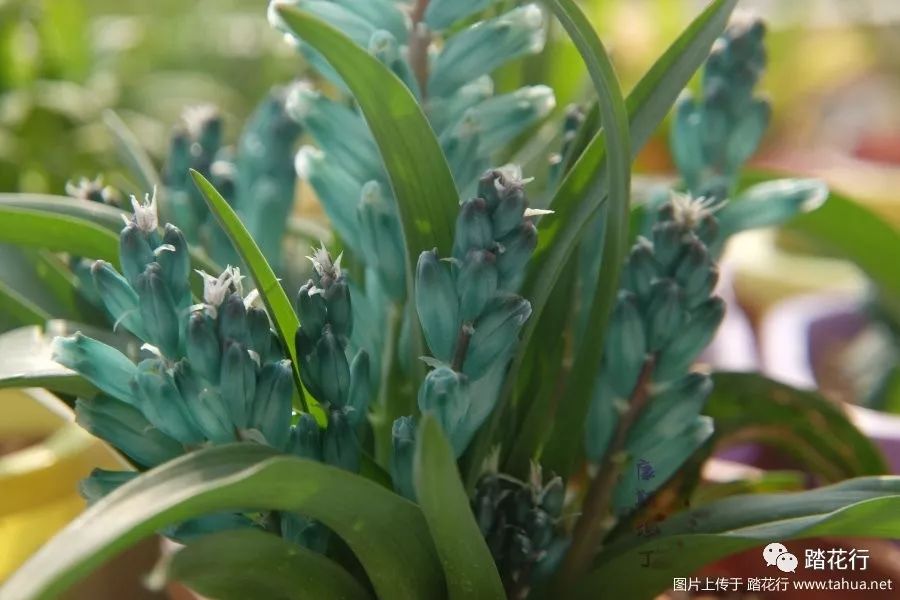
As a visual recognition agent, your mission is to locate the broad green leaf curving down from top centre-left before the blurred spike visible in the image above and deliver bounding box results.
[276,6,459,273]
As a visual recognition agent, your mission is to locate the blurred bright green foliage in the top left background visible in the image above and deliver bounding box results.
[0,0,301,193]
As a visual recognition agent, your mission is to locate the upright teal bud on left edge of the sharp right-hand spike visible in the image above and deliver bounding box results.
[604,291,647,396]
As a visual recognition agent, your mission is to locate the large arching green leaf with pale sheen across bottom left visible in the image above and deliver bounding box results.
[6,444,444,600]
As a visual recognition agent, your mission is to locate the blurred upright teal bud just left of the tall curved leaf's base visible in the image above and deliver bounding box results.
[357,181,406,299]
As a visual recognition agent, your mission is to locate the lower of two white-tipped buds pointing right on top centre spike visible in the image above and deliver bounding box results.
[472,85,556,154]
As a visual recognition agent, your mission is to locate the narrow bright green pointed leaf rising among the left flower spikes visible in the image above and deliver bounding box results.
[191,169,316,422]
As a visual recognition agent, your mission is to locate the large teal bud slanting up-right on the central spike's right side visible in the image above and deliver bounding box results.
[463,295,531,380]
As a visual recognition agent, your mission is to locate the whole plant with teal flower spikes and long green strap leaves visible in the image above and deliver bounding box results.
[4,0,900,599]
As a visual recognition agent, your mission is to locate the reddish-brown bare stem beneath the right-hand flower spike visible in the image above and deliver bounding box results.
[556,356,655,591]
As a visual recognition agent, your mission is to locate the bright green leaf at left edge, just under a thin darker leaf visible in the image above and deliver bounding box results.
[0,206,119,265]
